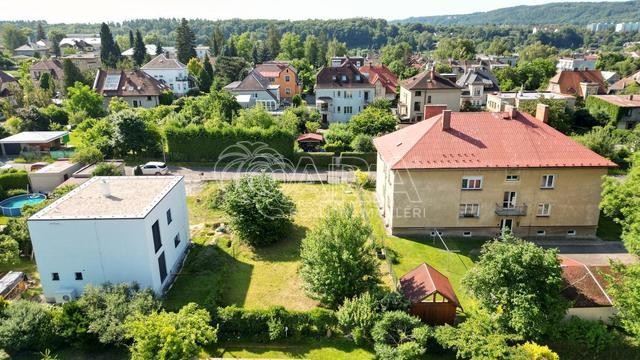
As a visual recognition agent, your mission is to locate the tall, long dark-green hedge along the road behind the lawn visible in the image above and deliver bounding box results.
[165,126,295,161]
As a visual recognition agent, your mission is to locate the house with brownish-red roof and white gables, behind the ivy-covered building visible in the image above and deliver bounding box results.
[547,70,607,99]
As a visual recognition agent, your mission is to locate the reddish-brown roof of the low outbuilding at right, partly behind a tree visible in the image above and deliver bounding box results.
[560,256,613,308]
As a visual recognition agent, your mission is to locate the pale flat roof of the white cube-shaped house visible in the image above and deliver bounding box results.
[29,176,182,220]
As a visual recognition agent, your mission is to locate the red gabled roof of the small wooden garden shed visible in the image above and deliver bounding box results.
[400,263,462,307]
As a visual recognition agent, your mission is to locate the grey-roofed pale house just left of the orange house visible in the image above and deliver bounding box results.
[224,70,280,111]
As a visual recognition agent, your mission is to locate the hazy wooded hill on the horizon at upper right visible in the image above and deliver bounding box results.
[394,1,640,25]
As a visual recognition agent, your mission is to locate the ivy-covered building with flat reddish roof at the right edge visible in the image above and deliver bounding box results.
[586,94,640,129]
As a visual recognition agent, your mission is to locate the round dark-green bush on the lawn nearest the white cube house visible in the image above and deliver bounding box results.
[224,174,295,246]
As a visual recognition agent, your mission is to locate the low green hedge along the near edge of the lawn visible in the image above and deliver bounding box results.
[212,306,337,342]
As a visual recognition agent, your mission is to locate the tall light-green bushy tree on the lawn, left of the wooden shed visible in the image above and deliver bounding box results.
[300,206,380,307]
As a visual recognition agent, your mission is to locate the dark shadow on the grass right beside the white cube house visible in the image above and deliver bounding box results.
[164,243,253,311]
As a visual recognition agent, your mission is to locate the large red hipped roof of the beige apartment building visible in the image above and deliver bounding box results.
[374,112,616,170]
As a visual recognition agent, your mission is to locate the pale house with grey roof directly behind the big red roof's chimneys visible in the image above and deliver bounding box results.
[456,69,500,108]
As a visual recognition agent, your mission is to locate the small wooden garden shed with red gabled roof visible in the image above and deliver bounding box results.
[400,263,462,325]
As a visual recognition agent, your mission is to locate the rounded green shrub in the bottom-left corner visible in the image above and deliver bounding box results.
[0,300,54,351]
